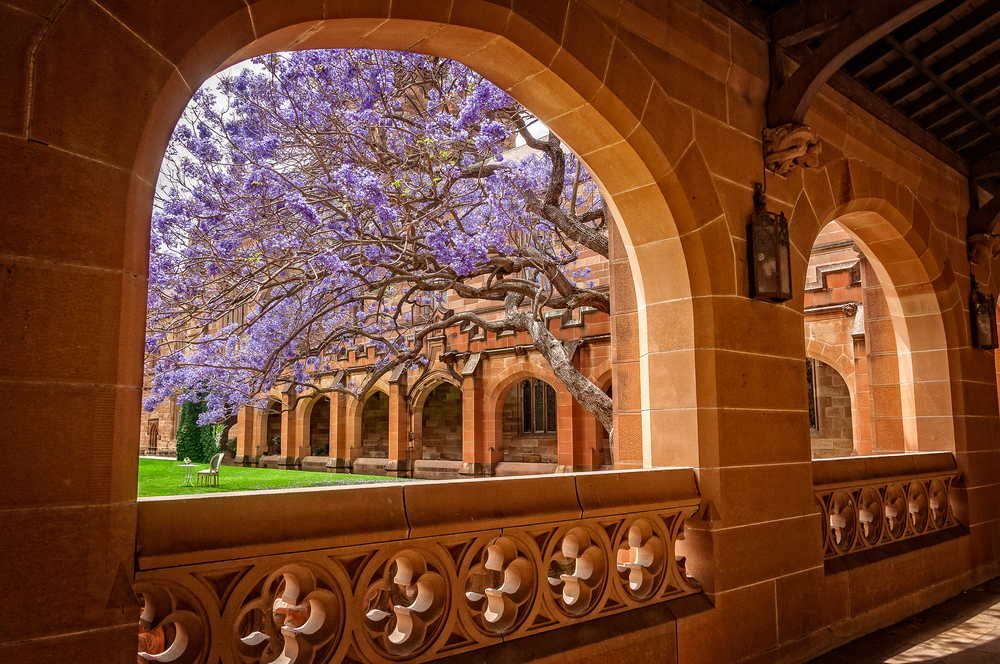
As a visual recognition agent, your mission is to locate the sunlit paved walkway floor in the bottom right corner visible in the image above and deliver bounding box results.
[812,578,1000,664]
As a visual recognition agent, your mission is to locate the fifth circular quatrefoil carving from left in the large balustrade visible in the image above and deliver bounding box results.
[546,527,607,617]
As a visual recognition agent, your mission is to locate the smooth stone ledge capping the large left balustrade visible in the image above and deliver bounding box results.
[137,468,699,570]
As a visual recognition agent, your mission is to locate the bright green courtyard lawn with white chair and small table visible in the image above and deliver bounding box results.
[139,459,413,498]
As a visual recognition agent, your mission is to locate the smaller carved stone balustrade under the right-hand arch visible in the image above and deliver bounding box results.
[813,452,958,559]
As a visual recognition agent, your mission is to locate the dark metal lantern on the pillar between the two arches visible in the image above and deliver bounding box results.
[747,182,792,302]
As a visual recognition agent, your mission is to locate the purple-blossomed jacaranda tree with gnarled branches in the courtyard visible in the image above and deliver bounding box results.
[145,51,612,446]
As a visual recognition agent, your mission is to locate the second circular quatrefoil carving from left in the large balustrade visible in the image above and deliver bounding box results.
[233,564,344,664]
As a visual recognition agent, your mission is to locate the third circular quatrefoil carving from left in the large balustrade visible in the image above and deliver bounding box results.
[362,550,450,657]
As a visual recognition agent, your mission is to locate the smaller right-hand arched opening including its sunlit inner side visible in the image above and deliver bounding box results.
[804,193,961,457]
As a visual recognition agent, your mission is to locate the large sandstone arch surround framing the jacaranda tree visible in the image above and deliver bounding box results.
[121,7,720,465]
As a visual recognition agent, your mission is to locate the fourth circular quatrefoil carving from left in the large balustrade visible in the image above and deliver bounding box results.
[465,537,538,635]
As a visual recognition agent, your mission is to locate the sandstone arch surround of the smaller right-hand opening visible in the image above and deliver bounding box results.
[790,160,968,451]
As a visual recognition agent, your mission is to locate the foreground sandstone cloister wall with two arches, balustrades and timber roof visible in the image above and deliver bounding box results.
[0,0,1000,664]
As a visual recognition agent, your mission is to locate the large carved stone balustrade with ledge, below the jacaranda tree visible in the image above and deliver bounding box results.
[135,469,700,664]
